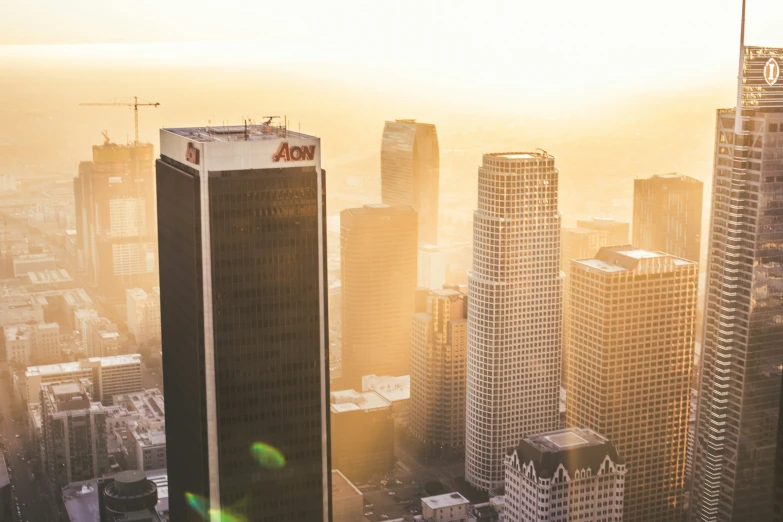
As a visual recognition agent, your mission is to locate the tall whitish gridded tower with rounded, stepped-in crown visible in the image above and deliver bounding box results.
[465,151,563,490]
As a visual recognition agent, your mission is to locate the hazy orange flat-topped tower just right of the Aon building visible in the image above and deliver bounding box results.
[340,204,417,390]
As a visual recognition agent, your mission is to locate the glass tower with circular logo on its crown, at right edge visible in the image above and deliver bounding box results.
[691,47,783,522]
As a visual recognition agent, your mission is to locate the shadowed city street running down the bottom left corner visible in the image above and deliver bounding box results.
[0,362,60,522]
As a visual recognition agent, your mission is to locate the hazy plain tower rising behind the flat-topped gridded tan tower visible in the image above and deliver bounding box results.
[632,173,704,263]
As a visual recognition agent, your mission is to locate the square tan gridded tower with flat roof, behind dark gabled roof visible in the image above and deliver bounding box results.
[566,246,698,522]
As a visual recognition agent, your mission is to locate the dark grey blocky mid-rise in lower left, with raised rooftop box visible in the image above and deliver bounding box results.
[41,379,109,487]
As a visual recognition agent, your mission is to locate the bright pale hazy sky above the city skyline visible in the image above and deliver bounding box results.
[0,0,783,94]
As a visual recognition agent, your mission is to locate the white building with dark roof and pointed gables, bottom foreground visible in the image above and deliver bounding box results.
[505,428,626,522]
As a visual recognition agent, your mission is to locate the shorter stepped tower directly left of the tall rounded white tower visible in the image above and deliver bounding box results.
[410,288,468,457]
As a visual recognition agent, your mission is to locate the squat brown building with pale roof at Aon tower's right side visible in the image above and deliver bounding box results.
[330,390,394,482]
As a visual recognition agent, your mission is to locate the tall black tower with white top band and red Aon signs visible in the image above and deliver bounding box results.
[157,125,331,522]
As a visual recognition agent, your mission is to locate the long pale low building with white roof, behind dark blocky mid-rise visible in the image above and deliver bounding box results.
[25,354,142,405]
